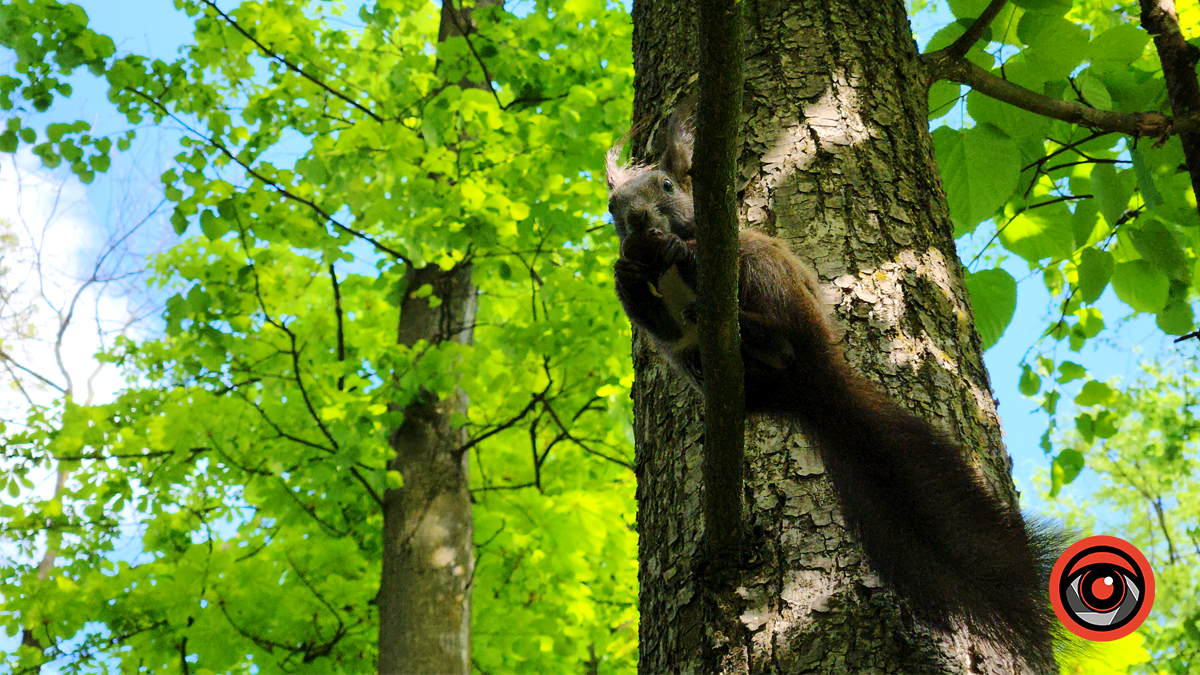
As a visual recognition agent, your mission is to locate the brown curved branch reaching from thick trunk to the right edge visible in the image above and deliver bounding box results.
[923,49,1200,138]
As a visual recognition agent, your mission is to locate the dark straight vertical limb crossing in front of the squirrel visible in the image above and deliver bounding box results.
[691,0,745,554]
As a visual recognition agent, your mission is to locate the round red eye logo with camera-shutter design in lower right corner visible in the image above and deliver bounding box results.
[1050,537,1154,643]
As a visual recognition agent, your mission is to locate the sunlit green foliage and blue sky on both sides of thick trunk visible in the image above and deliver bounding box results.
[0,0,1200,673]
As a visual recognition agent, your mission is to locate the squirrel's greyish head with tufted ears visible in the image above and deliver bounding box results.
[606,114,696,241]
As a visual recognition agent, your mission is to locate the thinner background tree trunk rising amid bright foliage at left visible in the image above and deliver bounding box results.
[378,0,499,675]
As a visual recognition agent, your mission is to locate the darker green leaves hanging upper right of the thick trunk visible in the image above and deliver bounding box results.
[926,0,1200,495]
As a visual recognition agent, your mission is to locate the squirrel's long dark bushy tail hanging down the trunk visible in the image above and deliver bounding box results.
[773,357,1066,673]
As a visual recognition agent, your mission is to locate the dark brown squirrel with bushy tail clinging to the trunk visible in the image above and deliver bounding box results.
[606,114,1063,673]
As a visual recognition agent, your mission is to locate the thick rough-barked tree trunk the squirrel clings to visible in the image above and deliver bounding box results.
[632,0,1018,675]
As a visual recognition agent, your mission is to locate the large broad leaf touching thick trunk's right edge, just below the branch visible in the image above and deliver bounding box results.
[932,124,1021,237]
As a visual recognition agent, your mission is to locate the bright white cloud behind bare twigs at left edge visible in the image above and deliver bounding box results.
[0,151,154,420]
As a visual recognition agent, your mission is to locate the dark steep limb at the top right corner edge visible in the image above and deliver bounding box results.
[1140,0,1200,220]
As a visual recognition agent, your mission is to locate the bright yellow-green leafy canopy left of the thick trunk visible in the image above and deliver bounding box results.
[0,0,636,673]
